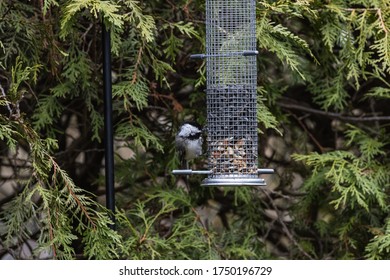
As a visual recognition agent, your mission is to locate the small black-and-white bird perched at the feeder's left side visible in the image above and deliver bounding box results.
[175,122,203,169]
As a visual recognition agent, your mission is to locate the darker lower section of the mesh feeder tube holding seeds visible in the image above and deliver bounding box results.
[207,85,257,175]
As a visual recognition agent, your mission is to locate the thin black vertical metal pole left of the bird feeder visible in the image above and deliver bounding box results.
[102,19,115,229]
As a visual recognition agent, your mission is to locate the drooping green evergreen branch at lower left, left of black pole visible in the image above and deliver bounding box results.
[1,115,120,259]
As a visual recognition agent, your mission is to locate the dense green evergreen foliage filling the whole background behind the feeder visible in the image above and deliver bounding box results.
[0,0,390,259]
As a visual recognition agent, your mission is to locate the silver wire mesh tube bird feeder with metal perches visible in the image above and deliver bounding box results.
[173,0,273,186]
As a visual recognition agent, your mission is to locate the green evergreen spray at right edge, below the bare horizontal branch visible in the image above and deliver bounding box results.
[294,126,390,258]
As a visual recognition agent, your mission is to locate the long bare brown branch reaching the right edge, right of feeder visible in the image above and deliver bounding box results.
[277,100,390,123]
